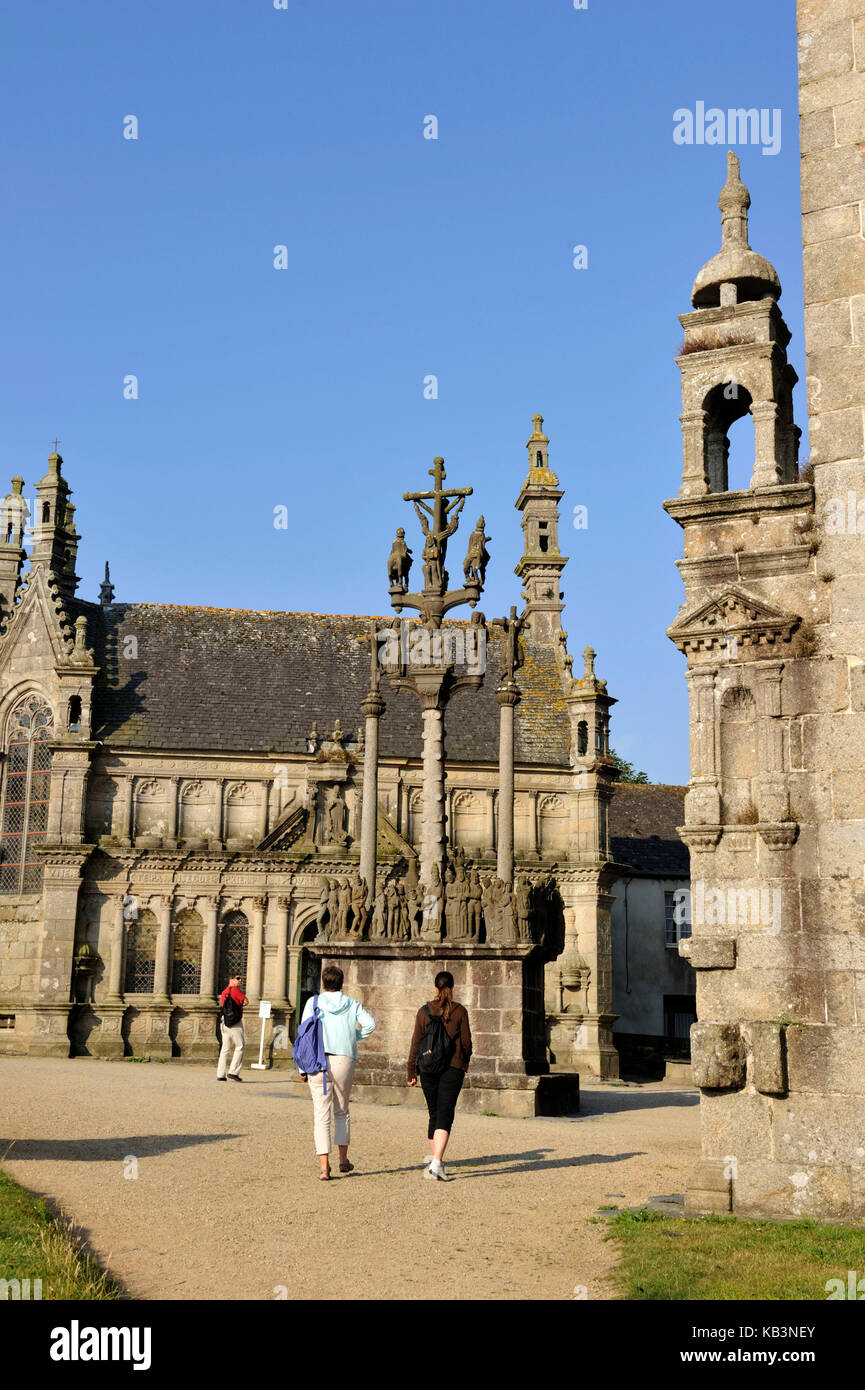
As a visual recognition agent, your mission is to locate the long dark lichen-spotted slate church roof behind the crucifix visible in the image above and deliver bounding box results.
[84,600,570,767]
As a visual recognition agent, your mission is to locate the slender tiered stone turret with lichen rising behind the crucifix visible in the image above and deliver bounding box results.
[513,416,567,642]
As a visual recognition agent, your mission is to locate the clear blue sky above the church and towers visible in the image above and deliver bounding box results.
[0,0,804,781]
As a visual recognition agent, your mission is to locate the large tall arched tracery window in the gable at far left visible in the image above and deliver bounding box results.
[0,695,54,892]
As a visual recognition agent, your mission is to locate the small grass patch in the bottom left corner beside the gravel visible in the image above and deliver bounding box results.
[0,1169,122,1300]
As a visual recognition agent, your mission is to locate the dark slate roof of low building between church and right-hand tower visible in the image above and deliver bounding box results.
[609,783,691,878]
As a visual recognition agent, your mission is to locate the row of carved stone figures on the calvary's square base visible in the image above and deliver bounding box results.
[317,853,555,945]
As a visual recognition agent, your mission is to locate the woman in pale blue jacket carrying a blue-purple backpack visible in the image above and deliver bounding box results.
[300,965,375,1182]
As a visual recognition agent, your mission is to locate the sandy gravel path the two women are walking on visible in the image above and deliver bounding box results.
[0,1058,700,1300]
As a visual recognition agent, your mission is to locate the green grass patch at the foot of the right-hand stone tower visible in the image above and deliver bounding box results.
[605,1211,865,1301]
